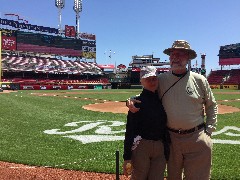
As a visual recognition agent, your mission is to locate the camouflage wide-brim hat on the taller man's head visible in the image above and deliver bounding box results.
[163,40,197,60]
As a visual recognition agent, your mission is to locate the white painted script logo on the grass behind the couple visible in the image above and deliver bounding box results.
[44,120,240,144]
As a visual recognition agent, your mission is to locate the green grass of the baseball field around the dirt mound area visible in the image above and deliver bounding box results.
[0,90,240,179]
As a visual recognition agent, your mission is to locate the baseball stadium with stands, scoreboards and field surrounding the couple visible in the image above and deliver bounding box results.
[0,0,240,180]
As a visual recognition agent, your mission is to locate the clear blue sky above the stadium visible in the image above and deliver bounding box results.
[0,0,240,72]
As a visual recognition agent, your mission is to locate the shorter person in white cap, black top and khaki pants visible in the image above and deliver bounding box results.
[123,66,170,180]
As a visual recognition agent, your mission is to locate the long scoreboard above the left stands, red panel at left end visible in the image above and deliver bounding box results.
[0,29,96,59]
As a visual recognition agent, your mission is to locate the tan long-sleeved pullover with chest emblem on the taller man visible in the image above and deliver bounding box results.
[158,71,217,133]
